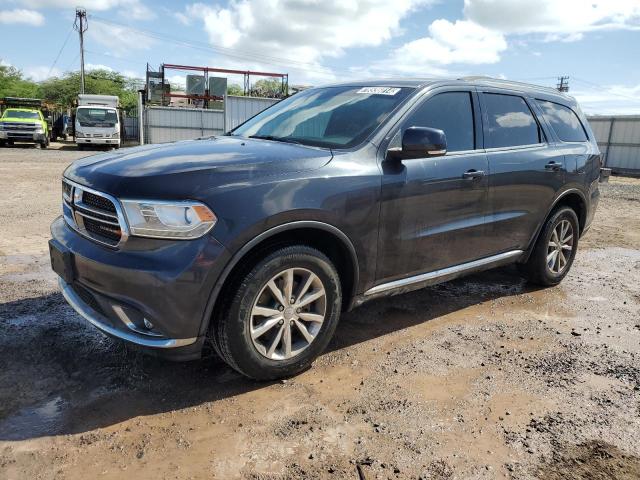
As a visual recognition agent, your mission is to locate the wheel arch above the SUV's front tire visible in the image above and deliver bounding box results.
[200,220,359,335]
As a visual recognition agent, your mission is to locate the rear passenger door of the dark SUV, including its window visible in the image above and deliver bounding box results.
[480,90,565,253]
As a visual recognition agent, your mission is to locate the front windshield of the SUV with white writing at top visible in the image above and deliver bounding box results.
[230,87,413,148]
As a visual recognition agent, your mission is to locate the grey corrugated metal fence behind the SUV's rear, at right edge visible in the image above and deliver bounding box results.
[588,115,640,176]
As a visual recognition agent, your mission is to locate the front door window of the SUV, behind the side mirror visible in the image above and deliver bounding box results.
[404,92,475,152]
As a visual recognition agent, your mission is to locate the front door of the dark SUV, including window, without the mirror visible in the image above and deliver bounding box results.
[376,88,488,283]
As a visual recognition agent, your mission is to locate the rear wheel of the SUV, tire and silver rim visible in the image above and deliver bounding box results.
[519,207,580,286]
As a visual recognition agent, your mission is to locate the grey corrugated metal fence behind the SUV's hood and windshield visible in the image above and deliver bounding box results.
[139,96,279,143]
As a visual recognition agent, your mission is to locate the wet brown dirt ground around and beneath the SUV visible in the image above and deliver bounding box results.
[0,143,640,480]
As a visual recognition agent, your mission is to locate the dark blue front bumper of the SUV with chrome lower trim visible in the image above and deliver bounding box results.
[51,217,228,360]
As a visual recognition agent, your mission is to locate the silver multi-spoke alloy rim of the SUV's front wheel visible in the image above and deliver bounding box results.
[249,268,327,360]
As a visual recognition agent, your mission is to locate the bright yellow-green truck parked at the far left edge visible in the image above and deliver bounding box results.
[0,98,49,148]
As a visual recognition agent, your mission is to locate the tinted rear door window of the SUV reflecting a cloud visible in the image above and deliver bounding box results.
[484,93,540,148]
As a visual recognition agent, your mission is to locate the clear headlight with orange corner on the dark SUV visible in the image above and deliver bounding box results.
[122,200,217,239]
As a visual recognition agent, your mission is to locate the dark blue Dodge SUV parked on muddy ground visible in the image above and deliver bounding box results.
[50,78,601,379]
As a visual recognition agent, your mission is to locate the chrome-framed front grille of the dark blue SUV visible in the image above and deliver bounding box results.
[63,180,122,247]
